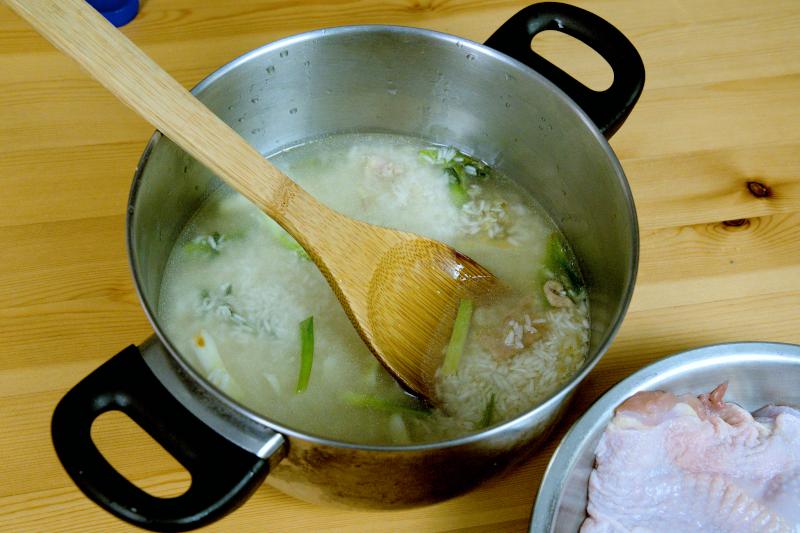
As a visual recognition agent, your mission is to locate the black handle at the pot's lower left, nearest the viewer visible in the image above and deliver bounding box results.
[51,346,276,531]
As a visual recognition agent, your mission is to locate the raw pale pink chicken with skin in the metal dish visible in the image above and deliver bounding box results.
[581,384,800,533]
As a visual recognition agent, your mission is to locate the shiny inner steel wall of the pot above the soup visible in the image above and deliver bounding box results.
[128,26,638,432]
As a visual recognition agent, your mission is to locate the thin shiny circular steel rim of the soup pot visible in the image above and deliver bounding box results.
[125,24,639,452]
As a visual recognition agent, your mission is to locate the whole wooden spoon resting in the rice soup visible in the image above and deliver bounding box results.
[5,0,496,401]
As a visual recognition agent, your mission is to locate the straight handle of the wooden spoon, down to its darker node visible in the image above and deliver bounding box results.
[5,0,318,231]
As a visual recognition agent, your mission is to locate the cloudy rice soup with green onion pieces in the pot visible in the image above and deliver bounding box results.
[158,135,589,444]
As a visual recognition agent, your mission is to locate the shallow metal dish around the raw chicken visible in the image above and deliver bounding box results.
[530,342,800,533]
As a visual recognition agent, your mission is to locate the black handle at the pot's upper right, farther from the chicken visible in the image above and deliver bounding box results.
[485,2,644,138]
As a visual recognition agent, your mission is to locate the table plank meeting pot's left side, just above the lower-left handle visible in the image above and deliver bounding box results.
[0,216,151,369]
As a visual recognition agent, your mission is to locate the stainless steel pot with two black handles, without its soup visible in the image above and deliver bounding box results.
[53,3,644,530]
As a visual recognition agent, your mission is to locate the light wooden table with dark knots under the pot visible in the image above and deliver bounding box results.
[0,0,800,533]
